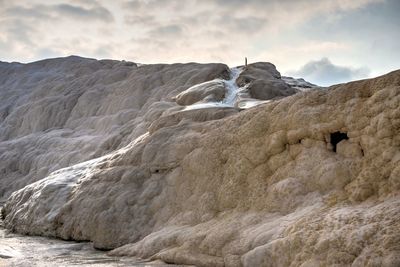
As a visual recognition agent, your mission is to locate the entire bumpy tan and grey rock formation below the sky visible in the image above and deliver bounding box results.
[0,58,400,267]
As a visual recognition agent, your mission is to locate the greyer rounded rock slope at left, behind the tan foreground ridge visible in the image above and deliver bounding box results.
[0,56,227,203]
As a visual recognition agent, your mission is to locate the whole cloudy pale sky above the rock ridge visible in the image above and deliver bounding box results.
[0,0,400,85]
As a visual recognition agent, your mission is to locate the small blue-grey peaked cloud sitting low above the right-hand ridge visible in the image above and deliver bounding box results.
[289,57,370,86]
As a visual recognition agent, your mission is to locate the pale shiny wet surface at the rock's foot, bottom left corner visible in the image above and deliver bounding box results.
[0,217,188,267]
